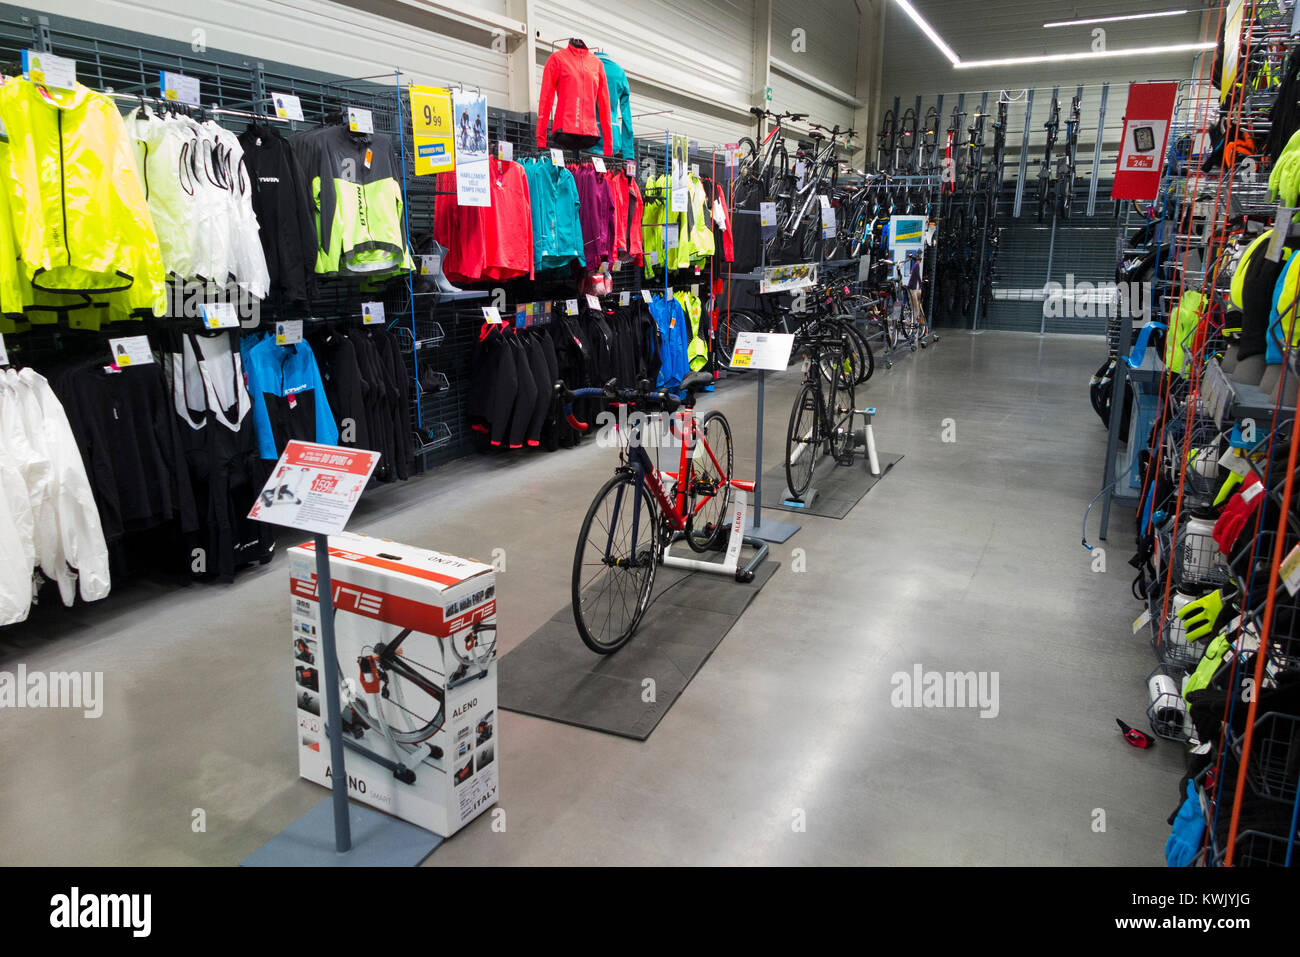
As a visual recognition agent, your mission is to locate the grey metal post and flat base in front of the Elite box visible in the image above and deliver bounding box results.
[242,534,442,867]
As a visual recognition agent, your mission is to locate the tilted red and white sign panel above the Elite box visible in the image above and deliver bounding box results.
[248,438,380,534]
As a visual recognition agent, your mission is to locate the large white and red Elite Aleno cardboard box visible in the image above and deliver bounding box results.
[289,533,498,836]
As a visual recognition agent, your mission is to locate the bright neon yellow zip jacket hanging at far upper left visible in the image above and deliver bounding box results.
[0,79,166,315]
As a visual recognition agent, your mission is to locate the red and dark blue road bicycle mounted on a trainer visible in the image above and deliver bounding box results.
[555,372,754,654]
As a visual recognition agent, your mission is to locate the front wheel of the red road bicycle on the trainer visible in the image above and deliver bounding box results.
[571,472,660,654]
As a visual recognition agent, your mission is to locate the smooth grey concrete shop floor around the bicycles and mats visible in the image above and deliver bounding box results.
[0,333,1182,865]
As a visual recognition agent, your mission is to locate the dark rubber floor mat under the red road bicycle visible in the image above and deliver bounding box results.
[497,561,780,741]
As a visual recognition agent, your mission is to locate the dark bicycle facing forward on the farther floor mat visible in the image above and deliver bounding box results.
[785,337,854,498]
